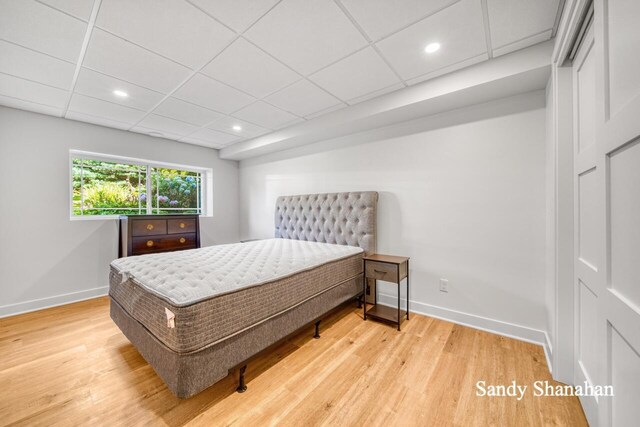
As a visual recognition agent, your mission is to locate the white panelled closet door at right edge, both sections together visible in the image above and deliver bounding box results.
[573,0,640,426]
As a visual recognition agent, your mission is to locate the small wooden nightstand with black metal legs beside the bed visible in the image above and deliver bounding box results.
[363,254,409,330]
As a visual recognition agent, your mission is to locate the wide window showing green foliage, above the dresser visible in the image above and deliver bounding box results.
[70,151,211,219]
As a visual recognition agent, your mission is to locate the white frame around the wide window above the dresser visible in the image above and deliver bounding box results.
[69,150,213,221]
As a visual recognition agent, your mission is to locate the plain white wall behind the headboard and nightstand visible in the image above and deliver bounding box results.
[240,91,547,342]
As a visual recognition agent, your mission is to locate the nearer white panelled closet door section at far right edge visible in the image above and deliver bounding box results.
[594,0,640,426]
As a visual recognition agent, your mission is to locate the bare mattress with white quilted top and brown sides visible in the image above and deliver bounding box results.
[109,239,363,353]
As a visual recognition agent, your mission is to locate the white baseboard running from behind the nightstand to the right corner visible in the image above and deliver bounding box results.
[378,292,551,372]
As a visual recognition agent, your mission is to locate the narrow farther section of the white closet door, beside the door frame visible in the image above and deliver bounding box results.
[573,22,605,425]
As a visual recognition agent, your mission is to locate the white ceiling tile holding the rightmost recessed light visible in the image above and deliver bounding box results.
[376,0,486,80]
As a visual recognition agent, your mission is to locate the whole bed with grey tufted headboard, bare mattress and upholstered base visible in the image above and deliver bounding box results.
[109,192,378,398]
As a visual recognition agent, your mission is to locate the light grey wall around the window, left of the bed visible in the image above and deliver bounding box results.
[0,107,239,316]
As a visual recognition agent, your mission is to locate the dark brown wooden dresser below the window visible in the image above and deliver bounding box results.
[118,215,200,258]
